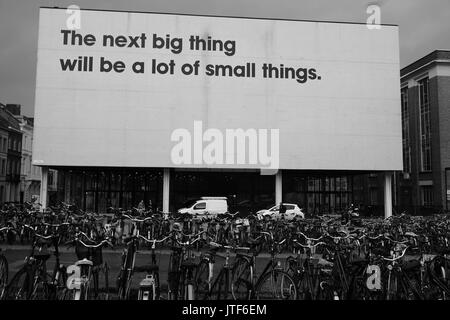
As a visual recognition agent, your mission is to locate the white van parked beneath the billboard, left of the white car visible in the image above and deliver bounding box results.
[178,197,228,216]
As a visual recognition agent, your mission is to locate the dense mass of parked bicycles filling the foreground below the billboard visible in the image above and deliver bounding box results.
[0,206,450,300]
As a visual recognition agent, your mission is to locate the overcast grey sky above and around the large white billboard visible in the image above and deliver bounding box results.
[0,0,450,116]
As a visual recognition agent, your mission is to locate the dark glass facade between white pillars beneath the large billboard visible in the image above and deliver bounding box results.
[49,168,376,216]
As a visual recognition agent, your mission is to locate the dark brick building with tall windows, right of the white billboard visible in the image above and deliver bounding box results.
[394,50,450,214]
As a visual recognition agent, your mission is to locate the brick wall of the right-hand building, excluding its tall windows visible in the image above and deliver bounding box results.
[395,53,450,213]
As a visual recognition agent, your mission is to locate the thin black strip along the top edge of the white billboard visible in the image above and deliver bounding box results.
[39,6,399,27]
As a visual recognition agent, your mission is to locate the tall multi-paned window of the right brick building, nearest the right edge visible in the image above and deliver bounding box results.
[419,78,431,171]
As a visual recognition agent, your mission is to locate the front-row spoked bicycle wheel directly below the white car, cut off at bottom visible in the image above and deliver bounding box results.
[255,270,297,300]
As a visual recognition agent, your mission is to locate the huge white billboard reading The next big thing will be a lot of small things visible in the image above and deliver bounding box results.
[33,8,402,170]
